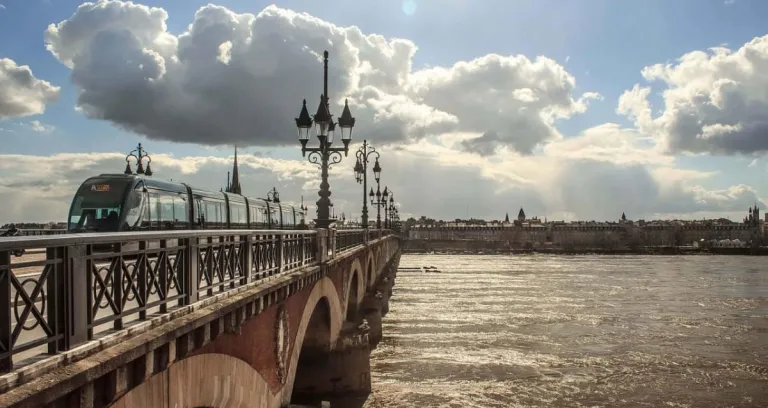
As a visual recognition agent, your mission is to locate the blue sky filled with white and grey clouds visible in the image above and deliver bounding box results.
[0,0,768,223]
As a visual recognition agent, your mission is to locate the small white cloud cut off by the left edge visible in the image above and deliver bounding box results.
[0,58,59,120]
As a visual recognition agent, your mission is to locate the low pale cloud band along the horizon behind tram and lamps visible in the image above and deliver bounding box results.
[0,142,759,223]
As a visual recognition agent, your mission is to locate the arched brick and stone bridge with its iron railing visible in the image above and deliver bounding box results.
[0,229,400,407]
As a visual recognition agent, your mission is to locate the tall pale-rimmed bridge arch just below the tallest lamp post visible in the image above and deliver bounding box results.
[281,277,344,404]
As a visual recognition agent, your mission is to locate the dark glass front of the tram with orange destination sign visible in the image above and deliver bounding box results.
[68,179,130,232]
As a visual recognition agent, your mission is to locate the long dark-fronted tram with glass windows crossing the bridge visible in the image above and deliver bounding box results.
[67,174,305,233]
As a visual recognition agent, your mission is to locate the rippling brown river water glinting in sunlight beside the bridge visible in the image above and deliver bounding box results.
[365,255,768,408]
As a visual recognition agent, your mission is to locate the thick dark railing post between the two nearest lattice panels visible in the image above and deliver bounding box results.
[68,244,93,349]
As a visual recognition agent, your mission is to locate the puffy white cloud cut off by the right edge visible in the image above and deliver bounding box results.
[617,35,768,155]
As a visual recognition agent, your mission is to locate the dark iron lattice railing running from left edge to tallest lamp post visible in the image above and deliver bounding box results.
[0,230,320,373]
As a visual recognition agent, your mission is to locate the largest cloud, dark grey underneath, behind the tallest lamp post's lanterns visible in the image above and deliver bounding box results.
[45,1,596,154]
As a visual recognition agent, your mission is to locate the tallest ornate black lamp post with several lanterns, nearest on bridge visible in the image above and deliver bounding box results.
[296,51,355,228]
